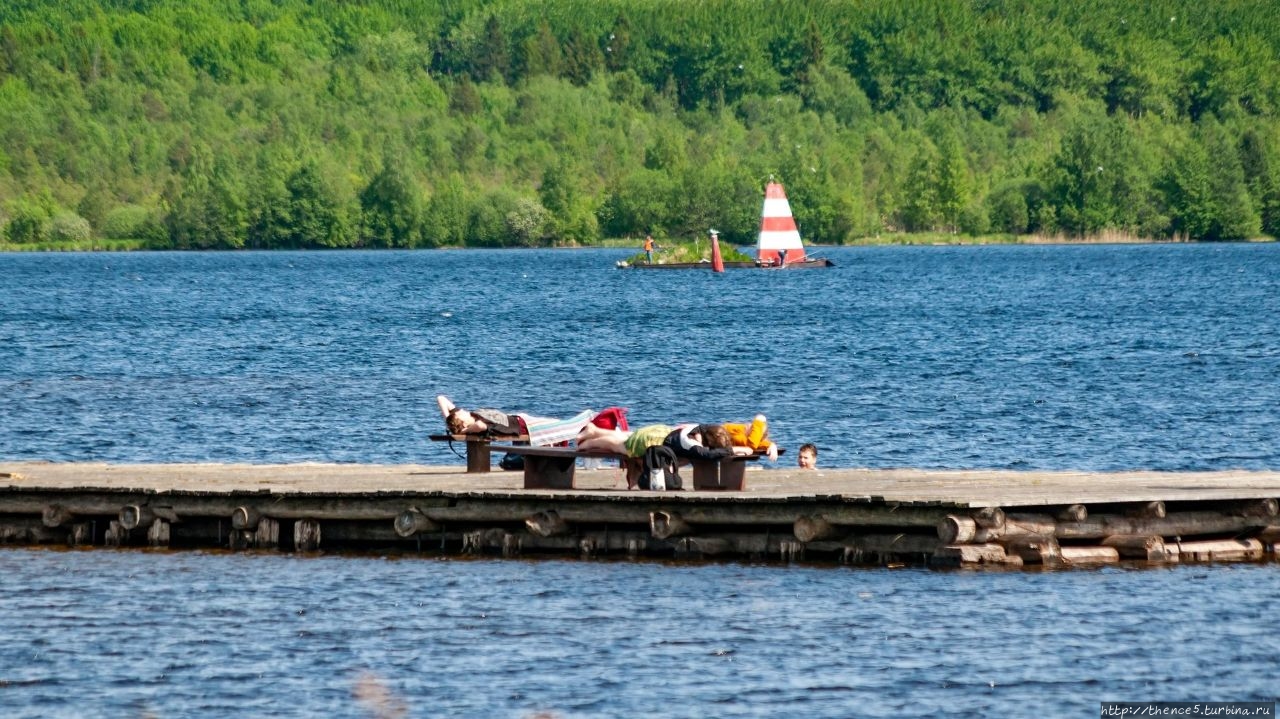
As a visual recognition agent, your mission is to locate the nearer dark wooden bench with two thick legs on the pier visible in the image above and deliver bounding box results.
[489,445,782,491]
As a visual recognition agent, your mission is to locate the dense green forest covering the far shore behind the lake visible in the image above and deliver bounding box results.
[0,0,1280,248]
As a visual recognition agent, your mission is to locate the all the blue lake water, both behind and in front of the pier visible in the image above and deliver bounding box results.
[0,244,1280,719]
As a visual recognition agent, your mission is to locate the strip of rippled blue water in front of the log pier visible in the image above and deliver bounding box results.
[0,549,1280,719]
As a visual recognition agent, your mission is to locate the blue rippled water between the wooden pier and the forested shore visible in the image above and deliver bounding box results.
[0,244,1280,470]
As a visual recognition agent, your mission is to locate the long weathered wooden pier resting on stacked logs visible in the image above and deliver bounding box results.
[0,462,1280,567]
